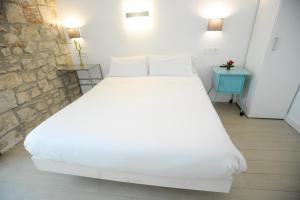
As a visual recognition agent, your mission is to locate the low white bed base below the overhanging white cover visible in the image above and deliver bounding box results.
[31,157,233,193]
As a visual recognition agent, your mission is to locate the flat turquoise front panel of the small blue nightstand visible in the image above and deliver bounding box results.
[217,75,245,93]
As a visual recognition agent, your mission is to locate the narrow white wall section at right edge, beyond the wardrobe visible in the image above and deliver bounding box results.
[285,87,300,133]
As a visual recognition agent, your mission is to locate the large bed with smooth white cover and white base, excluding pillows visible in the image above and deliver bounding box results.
[25,75,247,192]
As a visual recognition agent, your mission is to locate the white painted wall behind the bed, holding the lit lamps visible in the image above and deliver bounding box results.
[57,0,258,100]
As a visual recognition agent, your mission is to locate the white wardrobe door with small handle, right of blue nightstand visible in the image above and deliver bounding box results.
[248,0,300,119]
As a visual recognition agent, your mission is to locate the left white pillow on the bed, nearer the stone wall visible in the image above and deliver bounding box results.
[108,56,148,76]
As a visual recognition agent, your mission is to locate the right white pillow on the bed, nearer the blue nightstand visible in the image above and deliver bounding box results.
[149,55,193,76]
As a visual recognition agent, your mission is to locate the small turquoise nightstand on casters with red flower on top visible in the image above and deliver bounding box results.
[209,67,250,116]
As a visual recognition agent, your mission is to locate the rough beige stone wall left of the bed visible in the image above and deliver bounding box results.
[0,0,80,154]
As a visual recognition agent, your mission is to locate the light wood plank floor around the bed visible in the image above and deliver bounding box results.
[0,103,300,200]
